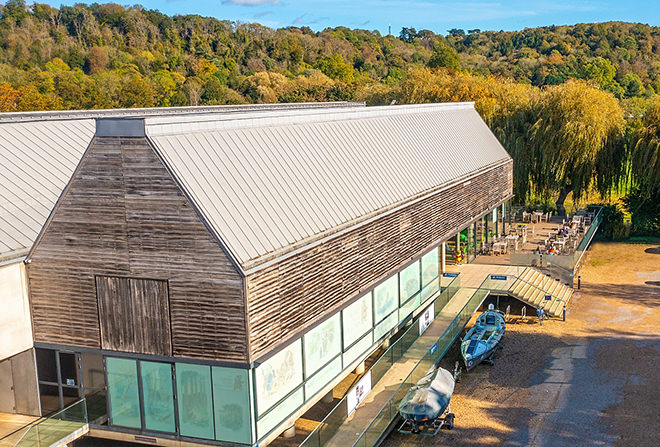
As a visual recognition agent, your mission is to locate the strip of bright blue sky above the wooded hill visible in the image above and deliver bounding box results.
[42,0,660,34]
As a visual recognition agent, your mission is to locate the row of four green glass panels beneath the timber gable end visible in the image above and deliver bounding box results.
[105,357,253,445]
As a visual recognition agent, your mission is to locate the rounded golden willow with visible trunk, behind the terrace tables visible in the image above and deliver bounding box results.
[529,81,624,214]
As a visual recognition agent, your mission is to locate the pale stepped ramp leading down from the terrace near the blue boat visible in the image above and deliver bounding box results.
[508,267,573,317]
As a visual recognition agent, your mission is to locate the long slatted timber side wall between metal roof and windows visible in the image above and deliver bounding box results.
[246,163,513,361]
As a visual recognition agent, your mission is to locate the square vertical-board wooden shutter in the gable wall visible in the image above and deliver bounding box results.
[96,276,172,356]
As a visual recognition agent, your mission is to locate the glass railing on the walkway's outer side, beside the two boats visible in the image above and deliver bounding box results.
[353,280,490,447]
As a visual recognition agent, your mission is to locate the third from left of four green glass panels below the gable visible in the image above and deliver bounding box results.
[176,363,214,439]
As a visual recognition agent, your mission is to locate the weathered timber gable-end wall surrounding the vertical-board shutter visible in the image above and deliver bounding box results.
[28,138,247,362]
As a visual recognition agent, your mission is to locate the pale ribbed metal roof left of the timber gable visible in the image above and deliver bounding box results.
[0,119,95,261]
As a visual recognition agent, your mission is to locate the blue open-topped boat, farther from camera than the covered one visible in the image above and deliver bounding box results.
[461,304,506,371]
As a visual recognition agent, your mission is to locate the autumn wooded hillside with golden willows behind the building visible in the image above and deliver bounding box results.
[0,0,660,232]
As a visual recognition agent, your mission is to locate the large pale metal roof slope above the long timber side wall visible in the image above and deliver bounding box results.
[150,103,510,270]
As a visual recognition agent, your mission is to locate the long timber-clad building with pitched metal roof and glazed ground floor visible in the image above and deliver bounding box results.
[2,103,512,445]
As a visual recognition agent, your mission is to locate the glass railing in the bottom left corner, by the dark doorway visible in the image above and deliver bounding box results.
[1,391,106,447]
